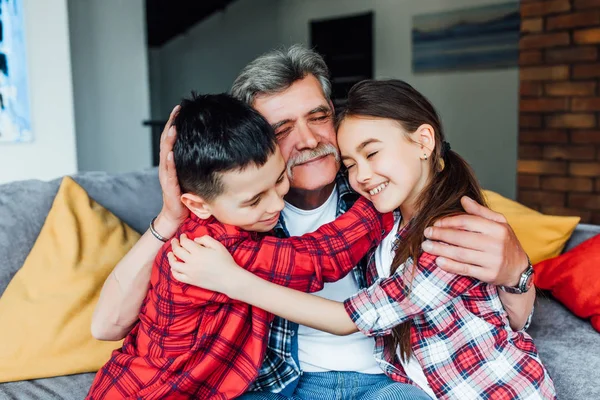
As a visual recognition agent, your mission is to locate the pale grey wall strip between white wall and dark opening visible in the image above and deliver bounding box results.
[68,0,151,172]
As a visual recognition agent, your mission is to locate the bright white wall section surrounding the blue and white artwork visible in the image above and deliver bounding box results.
[0,0,77,183]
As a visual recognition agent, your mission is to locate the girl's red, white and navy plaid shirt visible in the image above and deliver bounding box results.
[344,220,556,400]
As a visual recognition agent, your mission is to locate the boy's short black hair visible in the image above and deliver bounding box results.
[173,92,277,201]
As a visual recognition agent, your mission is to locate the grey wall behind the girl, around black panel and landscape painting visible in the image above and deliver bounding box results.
[279,0,519,198]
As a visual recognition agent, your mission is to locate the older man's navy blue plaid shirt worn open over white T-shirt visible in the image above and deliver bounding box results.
[248,170,367,393]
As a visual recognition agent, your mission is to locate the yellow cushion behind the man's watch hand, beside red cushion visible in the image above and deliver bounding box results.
[484,190,580,264]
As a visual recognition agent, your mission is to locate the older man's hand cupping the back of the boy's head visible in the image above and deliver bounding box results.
[154,106,189,237]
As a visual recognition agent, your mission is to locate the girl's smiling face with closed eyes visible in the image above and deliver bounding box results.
[338,116,435,221]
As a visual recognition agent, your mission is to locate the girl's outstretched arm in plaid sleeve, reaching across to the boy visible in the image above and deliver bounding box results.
[177,237,480,336]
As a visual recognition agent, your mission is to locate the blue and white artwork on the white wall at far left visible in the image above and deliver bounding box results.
[0,0,33,143]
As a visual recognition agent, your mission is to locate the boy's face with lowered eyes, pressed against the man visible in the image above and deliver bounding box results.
[206,146,290,232]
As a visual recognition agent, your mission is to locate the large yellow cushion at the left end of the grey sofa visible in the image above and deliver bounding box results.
[0,177,139,382]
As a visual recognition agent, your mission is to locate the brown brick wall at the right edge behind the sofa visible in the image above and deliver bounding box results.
[518,0,600,224]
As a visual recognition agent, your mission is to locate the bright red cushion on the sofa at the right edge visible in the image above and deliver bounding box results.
[534,235,600,332]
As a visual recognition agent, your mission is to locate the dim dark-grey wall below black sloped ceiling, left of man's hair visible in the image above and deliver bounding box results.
[150,0,281,120]
